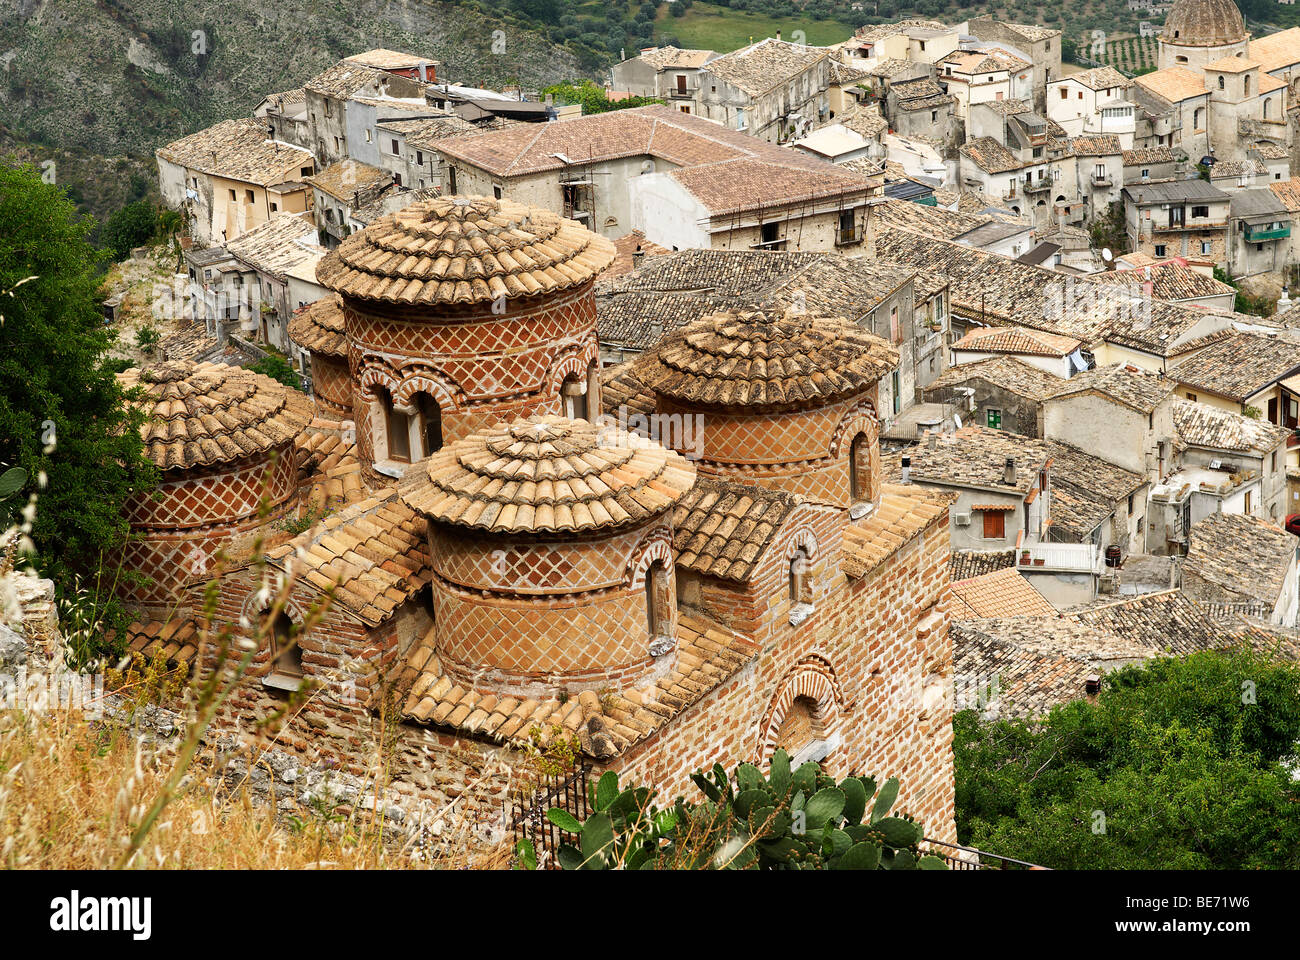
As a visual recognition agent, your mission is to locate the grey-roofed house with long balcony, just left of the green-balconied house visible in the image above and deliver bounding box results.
[1123,180,1231,264]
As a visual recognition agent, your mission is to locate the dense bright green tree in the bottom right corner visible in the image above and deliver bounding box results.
[953,649,1300,869]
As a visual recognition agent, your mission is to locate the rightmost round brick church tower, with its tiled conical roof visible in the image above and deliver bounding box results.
[647,311,898,507]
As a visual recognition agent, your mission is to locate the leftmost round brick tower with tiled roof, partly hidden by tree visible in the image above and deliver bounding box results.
[118,362,312,618]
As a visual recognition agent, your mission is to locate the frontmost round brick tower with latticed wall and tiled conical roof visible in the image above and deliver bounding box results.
[398,416,696,697]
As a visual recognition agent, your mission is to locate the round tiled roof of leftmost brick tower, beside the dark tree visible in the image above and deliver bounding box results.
[117,360,312,470]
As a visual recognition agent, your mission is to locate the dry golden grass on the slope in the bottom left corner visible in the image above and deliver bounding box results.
[0,686,510,870]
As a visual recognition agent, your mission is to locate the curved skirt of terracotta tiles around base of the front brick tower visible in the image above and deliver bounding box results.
[398,617,758,758]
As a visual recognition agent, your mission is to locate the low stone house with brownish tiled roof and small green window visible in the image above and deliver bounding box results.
[924,355,1065,438]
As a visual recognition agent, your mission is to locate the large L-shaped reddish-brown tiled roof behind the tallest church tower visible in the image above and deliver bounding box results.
[438,104,874,216]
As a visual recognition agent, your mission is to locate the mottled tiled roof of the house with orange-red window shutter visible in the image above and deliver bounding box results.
[891,427,1052,497]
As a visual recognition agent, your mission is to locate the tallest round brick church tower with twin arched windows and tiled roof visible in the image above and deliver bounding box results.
[317,196,614,484]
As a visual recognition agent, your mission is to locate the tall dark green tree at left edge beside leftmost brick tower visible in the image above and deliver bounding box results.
[0,161,156,588]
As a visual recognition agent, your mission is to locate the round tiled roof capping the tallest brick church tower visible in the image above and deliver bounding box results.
[316,196,614,304]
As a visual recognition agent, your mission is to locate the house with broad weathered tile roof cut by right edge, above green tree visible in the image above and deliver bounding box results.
[1180,514,1300,627]
